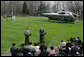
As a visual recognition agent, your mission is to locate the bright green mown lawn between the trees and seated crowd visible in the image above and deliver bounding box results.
[1,17,83,53]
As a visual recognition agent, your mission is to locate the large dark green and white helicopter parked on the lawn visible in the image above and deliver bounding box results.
[42,10,79,23]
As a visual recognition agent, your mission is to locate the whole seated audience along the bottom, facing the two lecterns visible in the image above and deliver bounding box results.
[10,37,83,56]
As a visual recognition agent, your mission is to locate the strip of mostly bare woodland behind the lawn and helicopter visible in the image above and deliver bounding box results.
[1,1,83,20]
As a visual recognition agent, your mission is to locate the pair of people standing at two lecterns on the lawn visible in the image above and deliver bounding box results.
[25,27,46,44]
